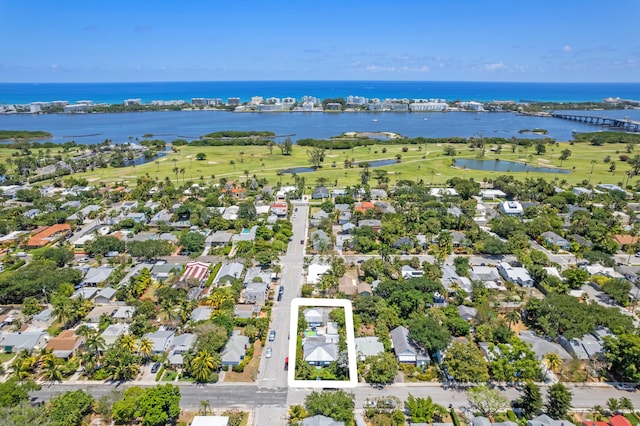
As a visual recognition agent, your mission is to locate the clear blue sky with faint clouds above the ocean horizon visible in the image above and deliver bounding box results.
[0,0,640,82]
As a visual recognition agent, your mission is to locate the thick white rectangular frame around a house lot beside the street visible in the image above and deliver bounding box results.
[287,297,358,389]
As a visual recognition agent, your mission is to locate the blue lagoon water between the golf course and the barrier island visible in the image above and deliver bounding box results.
[0,110,640,144]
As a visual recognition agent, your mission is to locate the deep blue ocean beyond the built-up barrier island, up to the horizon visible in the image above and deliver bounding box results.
[0,81,640,104]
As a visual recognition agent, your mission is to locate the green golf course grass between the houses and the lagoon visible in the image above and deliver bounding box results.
[5,142,638,186]
